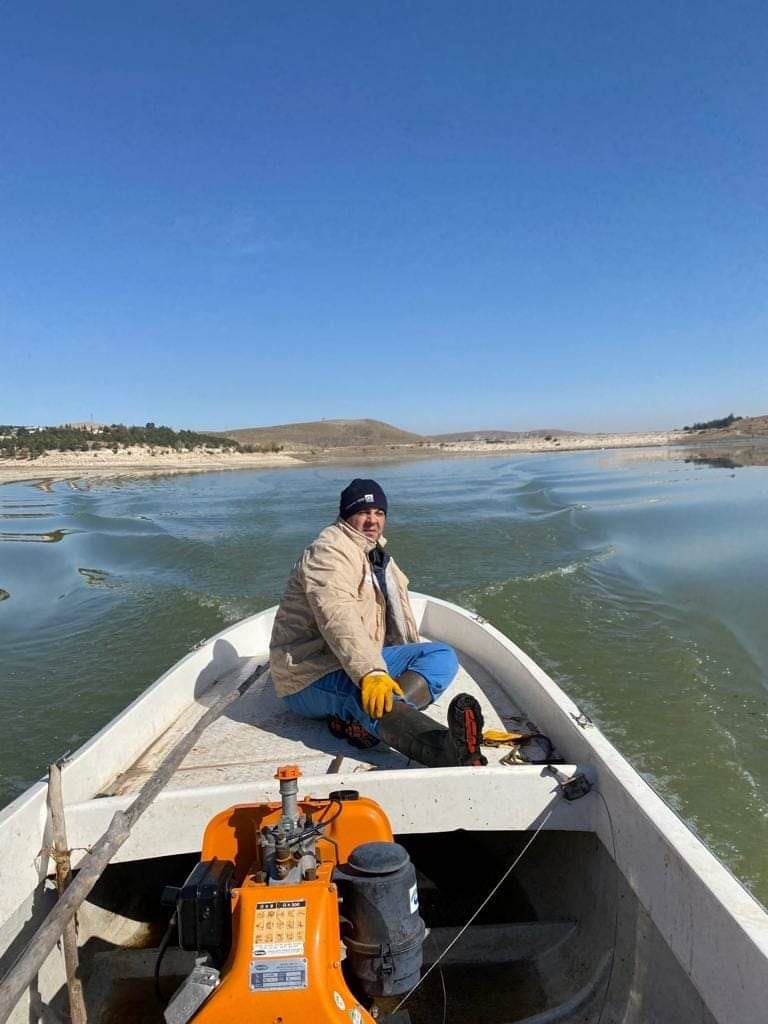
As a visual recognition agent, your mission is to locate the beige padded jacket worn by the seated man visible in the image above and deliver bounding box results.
[269,519,419,697]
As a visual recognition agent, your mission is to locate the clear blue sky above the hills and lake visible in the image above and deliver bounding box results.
[0,0,768,431]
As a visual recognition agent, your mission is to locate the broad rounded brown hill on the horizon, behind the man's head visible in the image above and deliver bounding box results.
[218,420,426,447]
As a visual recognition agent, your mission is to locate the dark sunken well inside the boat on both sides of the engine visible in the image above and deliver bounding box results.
[72,829,715,1024]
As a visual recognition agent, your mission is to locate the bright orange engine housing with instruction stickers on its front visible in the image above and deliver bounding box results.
[185,797,393,1024]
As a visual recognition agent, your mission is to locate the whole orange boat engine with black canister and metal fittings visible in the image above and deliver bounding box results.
[165,765,424,1024]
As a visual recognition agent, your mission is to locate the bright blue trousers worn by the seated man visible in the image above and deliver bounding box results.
[283,643,459,736]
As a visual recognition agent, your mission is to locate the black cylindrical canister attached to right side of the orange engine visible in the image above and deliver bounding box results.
[334,843,425,995]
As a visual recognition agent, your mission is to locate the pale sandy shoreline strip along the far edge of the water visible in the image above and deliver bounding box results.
[0,430,765,489]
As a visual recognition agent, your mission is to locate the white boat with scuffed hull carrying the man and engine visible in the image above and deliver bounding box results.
[0,594,768,1024]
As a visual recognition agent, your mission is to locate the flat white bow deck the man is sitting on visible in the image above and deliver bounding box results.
[100,651,561,796]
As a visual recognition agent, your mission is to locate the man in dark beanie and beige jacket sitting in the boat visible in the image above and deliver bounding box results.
[269,479,486,767]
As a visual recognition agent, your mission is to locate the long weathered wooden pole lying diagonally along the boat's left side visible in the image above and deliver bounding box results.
[0,658,267,1024]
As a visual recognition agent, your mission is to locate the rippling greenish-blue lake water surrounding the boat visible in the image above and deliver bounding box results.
[0,451,768,902]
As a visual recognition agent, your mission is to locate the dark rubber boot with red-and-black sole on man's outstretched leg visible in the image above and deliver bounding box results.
[379,693,487,768]
